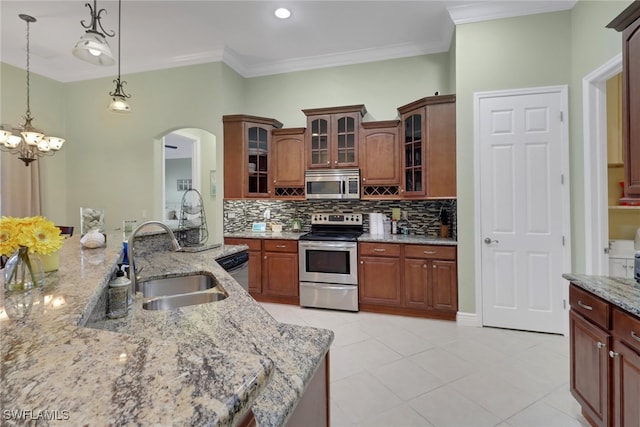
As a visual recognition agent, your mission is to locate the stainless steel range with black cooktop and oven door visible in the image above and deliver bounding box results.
[298,213,362,311]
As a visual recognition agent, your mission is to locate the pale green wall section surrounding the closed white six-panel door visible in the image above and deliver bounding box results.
[455,1,629,313]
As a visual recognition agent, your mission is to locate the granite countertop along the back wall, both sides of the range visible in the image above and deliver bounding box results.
[224,230,458,246]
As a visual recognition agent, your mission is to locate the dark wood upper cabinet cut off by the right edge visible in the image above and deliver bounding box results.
[607,1,640,205]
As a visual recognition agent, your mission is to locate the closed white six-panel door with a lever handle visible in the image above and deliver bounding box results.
[476,88,569,333]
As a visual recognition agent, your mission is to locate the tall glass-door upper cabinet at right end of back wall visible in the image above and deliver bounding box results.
[398,95,456,198]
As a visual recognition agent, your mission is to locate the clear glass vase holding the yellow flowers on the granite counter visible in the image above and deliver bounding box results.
[4,246,44,291]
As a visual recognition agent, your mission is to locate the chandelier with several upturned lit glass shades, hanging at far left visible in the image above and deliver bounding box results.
[0,14,64,166]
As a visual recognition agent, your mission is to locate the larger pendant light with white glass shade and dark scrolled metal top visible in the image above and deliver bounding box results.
[73,0,116,66]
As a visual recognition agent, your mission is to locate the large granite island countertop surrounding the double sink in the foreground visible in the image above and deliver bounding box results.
[0,236,333,426]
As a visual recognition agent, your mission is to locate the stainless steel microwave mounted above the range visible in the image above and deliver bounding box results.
[304,169,360,199]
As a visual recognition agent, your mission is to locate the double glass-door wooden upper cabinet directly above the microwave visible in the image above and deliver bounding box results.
[302,105,367,169]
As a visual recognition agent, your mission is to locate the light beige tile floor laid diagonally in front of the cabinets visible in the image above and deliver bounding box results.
[262,303,588,427]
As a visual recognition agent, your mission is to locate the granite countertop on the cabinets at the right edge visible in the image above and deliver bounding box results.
[562,274,640,317]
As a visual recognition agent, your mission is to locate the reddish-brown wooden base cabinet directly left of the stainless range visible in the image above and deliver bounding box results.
[262,239,299,304]
